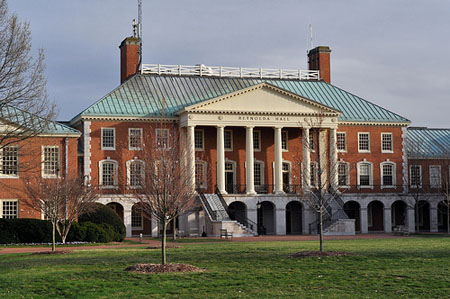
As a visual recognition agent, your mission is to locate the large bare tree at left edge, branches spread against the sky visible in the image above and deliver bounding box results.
[0,0,55,149]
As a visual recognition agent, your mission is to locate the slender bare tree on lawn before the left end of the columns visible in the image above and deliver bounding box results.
[134,122,198,264]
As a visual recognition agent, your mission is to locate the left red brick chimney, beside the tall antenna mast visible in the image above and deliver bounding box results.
[119,37,141,83]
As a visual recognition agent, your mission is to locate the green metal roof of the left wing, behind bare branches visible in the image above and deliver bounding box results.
[0,105,81,136]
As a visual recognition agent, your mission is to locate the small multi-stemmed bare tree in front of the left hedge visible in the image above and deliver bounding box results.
[23,176,97,251]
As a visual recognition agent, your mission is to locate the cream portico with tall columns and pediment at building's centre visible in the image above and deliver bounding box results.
[178,83,340,195]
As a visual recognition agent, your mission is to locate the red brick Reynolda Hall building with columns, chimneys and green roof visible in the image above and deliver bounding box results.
[0,37,450,236]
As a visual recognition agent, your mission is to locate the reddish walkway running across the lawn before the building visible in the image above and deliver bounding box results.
[0,234,422,255]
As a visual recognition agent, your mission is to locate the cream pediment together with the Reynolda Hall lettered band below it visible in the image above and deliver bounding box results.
[178,83,340,128]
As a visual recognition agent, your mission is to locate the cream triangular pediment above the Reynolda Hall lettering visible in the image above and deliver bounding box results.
[185,83,340,116]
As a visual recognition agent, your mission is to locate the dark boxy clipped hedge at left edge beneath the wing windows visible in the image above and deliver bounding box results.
[0,218,61,244]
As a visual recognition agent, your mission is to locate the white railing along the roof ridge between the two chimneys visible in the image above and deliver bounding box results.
[140,64,320,80]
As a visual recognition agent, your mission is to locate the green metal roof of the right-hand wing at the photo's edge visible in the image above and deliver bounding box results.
[407,127,450,159]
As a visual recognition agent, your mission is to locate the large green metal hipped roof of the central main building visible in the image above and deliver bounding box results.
[74,74,409,123]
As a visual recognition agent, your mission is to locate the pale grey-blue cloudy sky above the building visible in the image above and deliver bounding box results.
[8,0,450,128]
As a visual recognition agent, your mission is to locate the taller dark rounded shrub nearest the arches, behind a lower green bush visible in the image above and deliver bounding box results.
[78,204,126,242]
